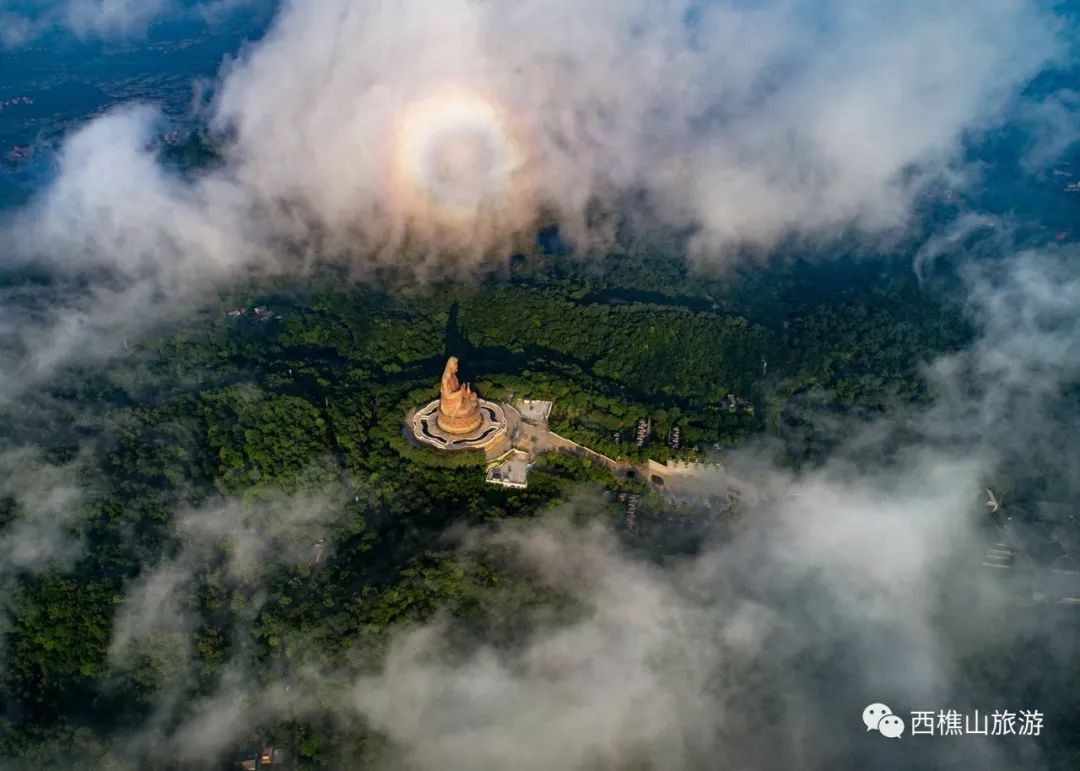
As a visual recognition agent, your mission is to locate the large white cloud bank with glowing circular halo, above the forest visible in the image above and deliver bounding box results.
[0,0,1066,395]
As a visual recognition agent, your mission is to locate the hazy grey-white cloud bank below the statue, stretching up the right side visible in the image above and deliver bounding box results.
[78,237,1080,771]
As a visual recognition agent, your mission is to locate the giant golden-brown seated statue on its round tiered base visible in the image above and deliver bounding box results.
[411,356,507,450]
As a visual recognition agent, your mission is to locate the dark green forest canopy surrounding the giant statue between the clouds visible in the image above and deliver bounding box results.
[0,250,964,768]
